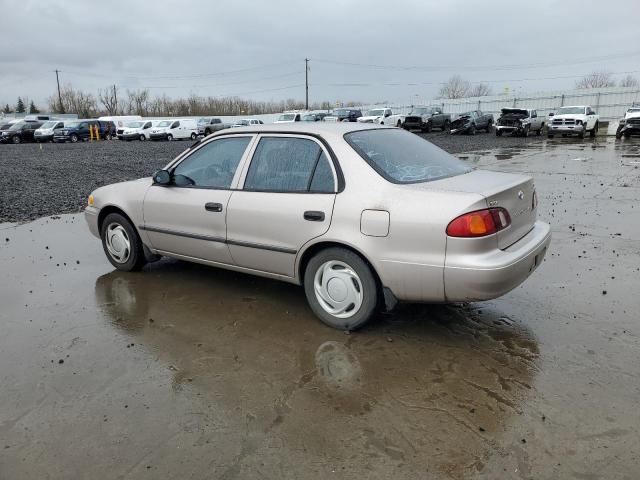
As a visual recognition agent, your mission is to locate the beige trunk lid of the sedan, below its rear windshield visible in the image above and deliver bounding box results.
[429,170,537,249]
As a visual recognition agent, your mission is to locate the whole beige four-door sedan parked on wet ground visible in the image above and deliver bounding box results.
[85,122,551,330]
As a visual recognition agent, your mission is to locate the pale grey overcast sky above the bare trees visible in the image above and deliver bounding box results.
[0,0,640,106]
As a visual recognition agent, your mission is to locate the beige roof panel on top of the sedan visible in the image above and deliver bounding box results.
[214,122,388,139]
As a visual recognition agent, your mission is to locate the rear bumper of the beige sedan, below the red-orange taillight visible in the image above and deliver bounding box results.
[444,222,551,302]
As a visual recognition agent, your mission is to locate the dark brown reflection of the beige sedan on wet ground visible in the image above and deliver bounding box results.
[95,266,540,478]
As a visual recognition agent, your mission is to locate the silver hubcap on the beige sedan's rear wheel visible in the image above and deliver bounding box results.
[313,260,363,318]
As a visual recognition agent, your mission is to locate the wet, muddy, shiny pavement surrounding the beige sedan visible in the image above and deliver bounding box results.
[0,134,640,480]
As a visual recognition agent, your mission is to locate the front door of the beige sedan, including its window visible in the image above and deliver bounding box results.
[140,135,253,264]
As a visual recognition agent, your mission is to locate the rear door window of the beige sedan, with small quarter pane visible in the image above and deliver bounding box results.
[244,137,335,193]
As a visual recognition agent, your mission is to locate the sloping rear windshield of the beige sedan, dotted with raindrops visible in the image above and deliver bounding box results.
[344,128,471,183]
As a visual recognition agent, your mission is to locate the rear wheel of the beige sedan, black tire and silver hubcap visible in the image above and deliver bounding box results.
[304,247,379,331]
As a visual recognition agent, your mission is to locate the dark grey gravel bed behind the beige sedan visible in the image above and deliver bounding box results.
[0,132,539,222]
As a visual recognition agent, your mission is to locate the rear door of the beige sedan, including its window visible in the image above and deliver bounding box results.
[227,134,338,277]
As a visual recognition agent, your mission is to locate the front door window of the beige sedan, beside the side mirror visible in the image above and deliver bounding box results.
[173,137,251,188]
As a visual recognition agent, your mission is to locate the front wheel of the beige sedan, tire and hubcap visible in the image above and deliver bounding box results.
[100,213,147,272]
